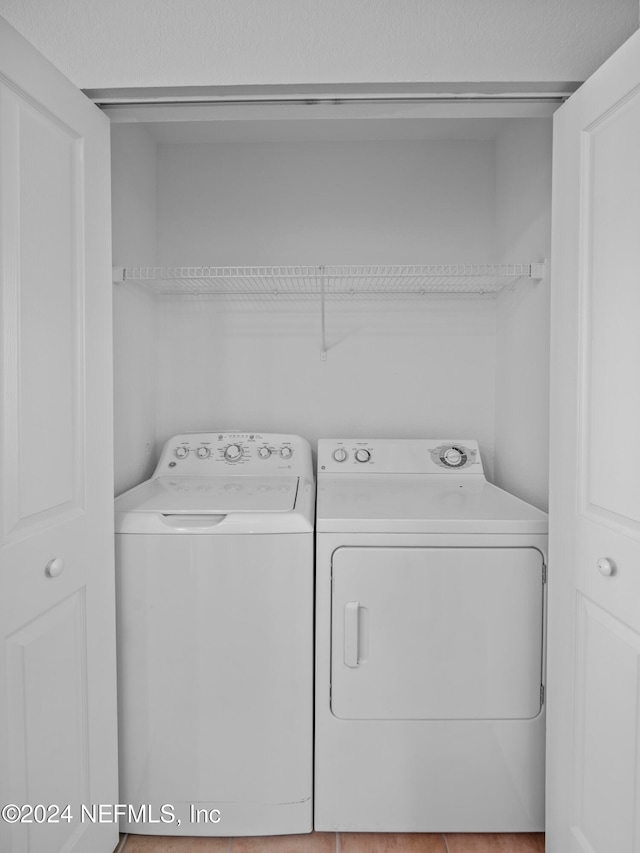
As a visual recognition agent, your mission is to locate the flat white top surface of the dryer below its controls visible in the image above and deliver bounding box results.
[316,474,548,533]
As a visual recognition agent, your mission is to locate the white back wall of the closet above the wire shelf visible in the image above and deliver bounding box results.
[158,140,495,265]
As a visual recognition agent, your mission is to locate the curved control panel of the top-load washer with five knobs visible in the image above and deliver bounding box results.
[153,432,311,477]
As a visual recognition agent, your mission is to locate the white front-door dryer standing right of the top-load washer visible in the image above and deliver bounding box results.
[314,439,547,832]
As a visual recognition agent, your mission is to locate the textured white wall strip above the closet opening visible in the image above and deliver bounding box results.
[0,0,638,88]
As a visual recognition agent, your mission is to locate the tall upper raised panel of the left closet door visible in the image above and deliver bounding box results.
[0,86,84,542]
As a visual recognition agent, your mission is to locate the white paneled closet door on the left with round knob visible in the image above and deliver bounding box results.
[0,19,118,853]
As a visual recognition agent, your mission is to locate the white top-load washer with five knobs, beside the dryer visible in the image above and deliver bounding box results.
[115,432,315,836]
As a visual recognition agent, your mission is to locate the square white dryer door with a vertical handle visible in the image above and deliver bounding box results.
[331,547,543,719]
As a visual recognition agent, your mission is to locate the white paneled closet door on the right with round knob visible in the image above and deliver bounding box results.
[547,25,640,853]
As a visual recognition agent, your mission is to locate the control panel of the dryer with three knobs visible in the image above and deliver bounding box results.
[318,438,484,475]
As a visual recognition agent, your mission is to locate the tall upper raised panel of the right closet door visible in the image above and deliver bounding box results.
[580,81,640,536]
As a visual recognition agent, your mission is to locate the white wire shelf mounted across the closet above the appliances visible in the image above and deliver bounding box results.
[113,263,545,297]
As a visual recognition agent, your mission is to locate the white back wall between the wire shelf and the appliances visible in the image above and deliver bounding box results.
[158,297,495,474]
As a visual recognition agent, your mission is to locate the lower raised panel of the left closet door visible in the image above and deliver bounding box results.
[5,590,91,853]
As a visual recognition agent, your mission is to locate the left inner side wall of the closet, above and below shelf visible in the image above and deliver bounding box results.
[111,120,158,494]
